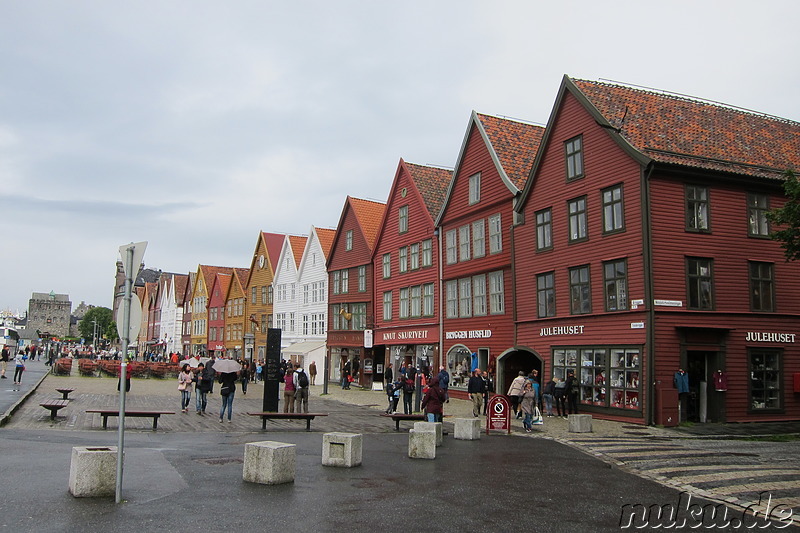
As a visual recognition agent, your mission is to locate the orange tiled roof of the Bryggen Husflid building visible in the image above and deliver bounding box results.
[476,113,545,190]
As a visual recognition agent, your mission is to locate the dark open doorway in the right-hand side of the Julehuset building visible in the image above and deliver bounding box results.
[686,351,725,422]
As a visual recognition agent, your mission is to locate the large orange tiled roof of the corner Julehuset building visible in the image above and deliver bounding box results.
[571,79,800,178]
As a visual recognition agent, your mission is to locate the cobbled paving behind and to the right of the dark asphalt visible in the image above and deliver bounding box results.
[7,366,800,522]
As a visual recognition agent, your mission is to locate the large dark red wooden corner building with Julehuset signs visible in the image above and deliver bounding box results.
[513,77,800,424]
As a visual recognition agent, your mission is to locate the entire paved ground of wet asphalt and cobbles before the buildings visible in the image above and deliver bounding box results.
[0,362,800,531]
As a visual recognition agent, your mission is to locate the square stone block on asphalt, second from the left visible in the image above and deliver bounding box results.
[242,440,297,485]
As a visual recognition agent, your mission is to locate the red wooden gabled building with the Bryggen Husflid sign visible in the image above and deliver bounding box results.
[436,112,544,392]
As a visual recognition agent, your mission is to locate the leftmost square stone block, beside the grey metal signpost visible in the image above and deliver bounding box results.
[69,446,117,498]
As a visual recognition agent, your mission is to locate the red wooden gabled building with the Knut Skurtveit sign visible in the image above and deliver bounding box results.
[372,159,453,381]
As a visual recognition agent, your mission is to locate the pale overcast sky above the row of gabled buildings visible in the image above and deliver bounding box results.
[0,0,800,310]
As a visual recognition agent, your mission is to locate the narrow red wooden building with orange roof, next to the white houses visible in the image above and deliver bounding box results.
[326,196,386,385]
